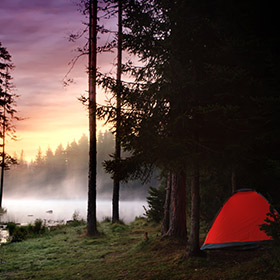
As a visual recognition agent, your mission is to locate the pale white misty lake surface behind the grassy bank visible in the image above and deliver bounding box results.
[0,199,147,224]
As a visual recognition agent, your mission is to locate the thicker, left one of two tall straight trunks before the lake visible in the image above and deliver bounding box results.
[87,0,98,236]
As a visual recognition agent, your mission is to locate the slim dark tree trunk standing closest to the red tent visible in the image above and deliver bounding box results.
[187,164,201,257]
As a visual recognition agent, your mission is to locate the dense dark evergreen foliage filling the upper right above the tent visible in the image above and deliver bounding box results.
[97,0,280,213]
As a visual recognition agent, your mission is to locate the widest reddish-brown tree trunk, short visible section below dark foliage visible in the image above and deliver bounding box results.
[165,171,187,241]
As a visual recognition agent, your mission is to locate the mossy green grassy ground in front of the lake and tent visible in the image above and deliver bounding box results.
[0,219,280,280]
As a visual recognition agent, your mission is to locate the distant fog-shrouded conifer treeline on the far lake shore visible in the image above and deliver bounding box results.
[4,132,152,199]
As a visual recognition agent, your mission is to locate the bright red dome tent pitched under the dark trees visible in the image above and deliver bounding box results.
[201,189,271,250]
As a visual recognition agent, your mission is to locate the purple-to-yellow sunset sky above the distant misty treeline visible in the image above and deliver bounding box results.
[0,0,113,160]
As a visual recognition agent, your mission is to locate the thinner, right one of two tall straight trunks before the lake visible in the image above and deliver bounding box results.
[112,0,122,223]
